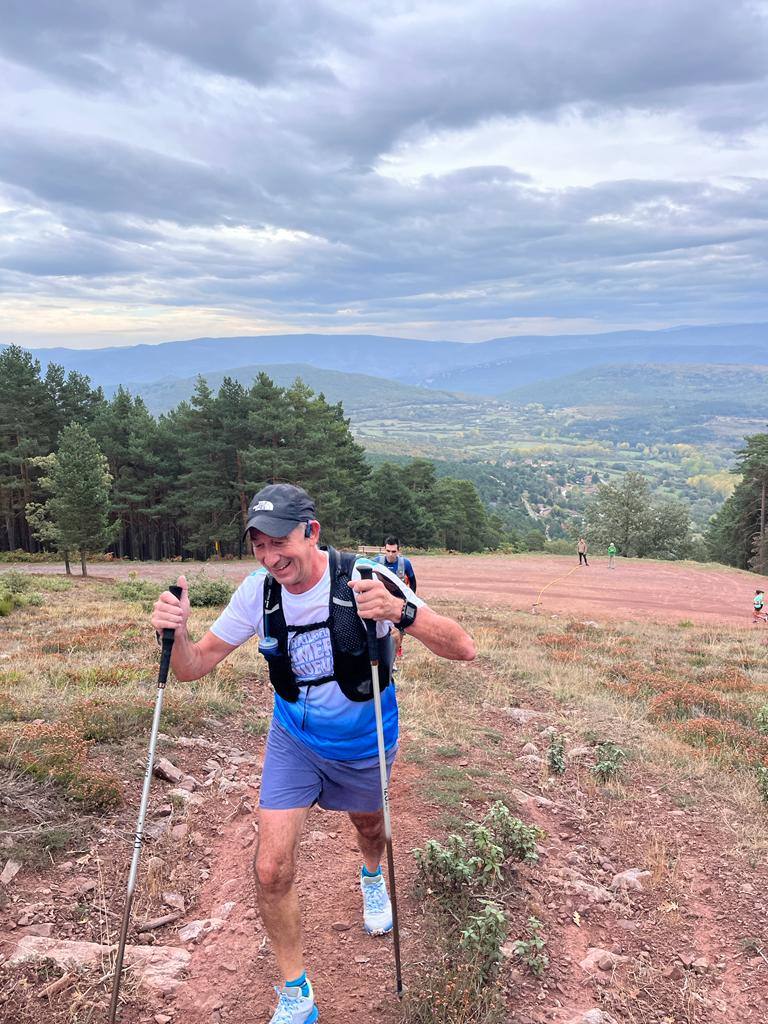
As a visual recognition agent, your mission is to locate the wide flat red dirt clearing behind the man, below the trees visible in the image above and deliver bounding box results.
[15,555,761,626]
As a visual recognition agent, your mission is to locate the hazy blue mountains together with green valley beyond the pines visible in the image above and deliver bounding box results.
[6,324,768,536]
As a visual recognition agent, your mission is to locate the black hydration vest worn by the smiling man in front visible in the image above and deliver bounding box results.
[264,547,392,703]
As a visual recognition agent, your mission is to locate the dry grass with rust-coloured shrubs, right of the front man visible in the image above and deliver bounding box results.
[398,605,768,856]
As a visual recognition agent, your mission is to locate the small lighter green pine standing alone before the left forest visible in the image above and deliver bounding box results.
[47,423,112,575]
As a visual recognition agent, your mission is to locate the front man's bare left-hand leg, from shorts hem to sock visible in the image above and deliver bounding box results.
[253,807,309,981]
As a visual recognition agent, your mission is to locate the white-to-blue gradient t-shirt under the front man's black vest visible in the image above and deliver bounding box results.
[211,566,424,761]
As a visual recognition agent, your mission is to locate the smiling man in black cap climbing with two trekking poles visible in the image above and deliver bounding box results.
[152,483,475,1024]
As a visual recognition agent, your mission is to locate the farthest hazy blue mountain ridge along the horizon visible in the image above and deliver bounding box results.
[7,324,768,395]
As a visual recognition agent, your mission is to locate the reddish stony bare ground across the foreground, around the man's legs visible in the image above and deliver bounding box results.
[0,688,768,1024]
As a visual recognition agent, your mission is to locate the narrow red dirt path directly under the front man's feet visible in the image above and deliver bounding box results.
[124,749,433,1024]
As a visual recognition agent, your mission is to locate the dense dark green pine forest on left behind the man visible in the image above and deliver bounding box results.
[0,347,504,564]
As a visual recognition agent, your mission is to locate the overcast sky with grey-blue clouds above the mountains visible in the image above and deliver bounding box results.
[0,0,768,347]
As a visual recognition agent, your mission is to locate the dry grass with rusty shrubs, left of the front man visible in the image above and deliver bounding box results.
[0,578,244,863]
